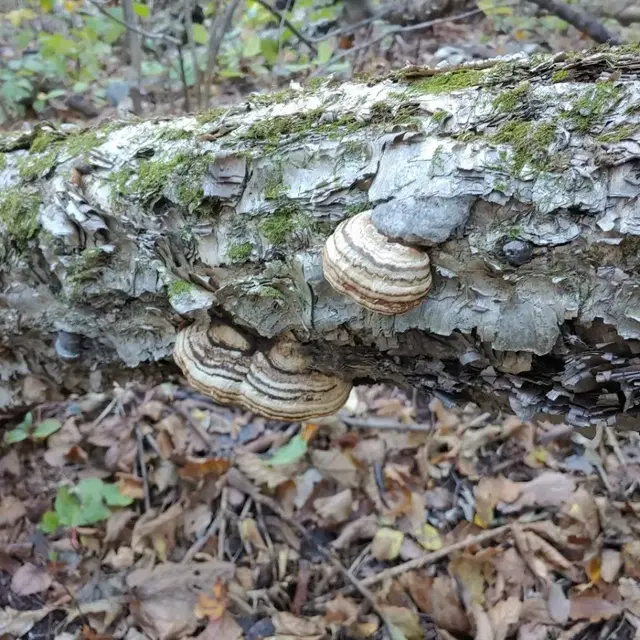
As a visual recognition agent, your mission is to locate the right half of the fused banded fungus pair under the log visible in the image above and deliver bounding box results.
[242,341,351,421]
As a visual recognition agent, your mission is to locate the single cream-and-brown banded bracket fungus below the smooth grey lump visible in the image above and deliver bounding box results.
[322,211,432,315]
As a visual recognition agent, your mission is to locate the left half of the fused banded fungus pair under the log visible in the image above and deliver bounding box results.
[173,321,252,404]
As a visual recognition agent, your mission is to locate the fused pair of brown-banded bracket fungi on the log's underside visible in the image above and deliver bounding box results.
[174,321,352,421]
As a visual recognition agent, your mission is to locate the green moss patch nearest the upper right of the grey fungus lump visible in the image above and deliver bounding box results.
[490,120,556,175]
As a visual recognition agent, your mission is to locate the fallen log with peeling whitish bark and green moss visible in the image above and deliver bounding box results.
[0,49,640,424]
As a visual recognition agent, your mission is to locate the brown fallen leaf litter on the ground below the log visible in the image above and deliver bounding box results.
[0,384,640,640]
